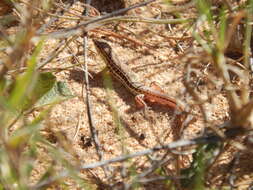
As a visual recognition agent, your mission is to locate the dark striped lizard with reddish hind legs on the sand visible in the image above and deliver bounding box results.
[93,40,183,112]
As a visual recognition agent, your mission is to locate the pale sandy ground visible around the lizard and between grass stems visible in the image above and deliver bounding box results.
[2,0,253,189]
